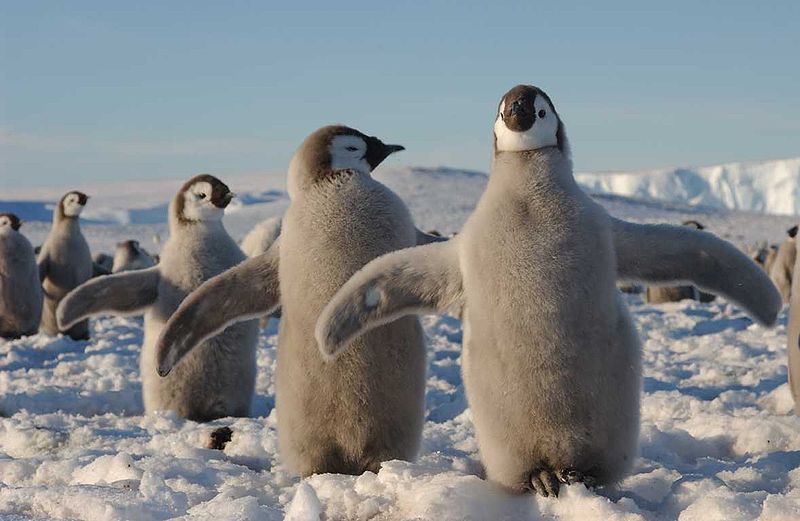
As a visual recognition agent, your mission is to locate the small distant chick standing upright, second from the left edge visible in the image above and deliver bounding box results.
[38,191,94,340]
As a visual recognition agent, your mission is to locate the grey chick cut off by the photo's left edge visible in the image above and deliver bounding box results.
[0,213,42,338]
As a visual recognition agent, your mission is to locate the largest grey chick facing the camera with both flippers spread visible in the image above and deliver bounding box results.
[316,85,780,495]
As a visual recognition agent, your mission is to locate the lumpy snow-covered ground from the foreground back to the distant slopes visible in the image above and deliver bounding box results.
[0,168,800,521]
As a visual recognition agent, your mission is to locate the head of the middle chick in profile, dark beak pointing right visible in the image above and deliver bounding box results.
[289,125,405,195]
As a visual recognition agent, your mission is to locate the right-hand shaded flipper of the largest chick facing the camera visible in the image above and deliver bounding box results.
[612,219,782,325]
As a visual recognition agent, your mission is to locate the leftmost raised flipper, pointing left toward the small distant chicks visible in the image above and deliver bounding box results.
[56,268,161,331]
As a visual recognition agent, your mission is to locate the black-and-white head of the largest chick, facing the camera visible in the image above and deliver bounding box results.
[494,85,568,153]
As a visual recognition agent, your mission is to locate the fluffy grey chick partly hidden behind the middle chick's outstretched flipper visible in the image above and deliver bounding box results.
[58,175,258,421]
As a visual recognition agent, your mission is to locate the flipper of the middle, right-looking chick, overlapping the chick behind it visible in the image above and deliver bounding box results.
[156,241,280,376]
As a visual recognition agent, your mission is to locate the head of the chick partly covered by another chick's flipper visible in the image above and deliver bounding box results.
[173,174,234,223]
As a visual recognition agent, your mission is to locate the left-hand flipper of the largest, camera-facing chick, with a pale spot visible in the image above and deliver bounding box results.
[315,239,463,358]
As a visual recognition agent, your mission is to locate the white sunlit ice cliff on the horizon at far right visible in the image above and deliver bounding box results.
[576,157,800,215]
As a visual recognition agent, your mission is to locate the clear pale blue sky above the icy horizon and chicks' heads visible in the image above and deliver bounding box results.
[0,0,800,187]
